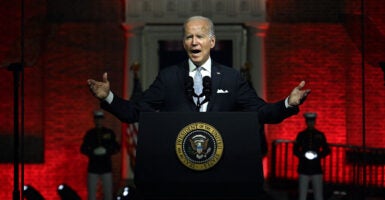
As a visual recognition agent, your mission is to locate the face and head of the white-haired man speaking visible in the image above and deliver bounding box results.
[183,20,215,66]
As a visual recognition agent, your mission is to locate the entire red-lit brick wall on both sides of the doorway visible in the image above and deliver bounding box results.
[0,0,385,199]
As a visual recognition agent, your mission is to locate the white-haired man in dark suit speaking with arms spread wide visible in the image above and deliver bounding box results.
[87,16,310,124]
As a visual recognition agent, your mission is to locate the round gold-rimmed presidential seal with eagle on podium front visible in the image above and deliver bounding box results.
[175,122,223,171]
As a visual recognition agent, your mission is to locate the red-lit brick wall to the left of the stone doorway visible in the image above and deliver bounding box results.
[0,1,125,199]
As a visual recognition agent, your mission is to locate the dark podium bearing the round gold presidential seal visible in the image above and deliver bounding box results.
[135,112,263,200]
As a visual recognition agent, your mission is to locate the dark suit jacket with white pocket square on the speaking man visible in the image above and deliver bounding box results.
[101,61,298,124]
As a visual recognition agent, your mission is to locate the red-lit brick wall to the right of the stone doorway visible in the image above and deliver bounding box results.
[265,1,385,157]
